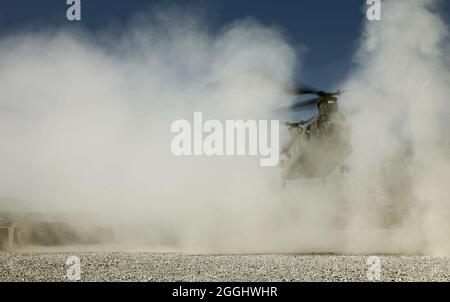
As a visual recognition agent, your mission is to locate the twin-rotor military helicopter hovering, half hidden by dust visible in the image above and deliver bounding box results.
[277,87,352,183]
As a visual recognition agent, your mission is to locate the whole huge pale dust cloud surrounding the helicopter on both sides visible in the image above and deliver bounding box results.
[0,0,450,254]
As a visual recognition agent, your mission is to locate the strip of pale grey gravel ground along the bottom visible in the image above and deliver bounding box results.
[0,252,450,281]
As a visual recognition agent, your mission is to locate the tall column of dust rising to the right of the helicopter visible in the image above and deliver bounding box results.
[342,0,450,255]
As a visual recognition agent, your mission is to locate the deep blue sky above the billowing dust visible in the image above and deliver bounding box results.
[0,0,450,89]
